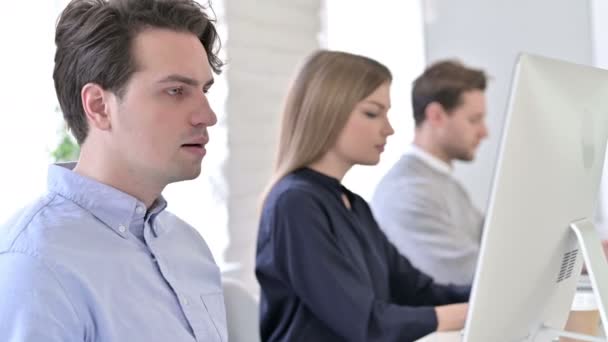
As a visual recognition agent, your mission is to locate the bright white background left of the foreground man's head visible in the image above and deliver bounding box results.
[0,0,61,223]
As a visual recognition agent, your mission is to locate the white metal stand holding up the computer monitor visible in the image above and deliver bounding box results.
[541,219,608,342]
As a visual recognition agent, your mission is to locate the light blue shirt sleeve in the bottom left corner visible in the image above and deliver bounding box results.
[0,253,85,342]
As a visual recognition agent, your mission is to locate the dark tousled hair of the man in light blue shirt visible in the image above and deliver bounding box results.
[53,0,223,144]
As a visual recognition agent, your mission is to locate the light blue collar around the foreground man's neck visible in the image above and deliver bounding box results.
[48,163,167,238]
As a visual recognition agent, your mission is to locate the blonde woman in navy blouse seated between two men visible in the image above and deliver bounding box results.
[256,50,470,342]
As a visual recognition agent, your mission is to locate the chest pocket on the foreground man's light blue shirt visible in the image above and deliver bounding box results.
[187,292,228,342]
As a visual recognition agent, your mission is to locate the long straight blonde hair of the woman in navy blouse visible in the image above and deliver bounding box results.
[262,50,392,203]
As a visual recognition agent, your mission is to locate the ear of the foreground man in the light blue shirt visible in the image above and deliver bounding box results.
[80,83,114,131]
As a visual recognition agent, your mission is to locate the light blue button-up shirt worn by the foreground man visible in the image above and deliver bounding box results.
[0,165,227,342]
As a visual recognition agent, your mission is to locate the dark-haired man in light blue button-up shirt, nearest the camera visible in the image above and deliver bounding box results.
[0,0,227,342]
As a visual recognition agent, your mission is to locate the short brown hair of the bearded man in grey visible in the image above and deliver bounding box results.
[412,60,487,126]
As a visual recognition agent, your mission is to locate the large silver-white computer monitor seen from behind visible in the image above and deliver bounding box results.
[463,54,608,342]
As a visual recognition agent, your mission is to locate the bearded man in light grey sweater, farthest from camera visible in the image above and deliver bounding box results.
[371,60,487,284]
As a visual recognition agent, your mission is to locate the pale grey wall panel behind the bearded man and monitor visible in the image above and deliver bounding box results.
[423,0,593,211]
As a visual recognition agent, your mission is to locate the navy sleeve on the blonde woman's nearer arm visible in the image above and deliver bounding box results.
[271,190,437,342]
